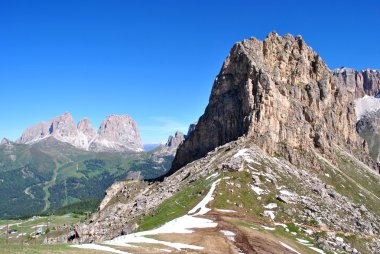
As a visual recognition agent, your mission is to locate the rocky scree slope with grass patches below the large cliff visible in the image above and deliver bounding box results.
[78,137,380,253]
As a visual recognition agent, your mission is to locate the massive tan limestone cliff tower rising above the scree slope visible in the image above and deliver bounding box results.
[169,33,370,174]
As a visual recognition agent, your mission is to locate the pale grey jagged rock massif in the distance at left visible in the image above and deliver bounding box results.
[16,113,143,152]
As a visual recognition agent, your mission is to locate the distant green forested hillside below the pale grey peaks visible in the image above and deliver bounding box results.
[0,137,173,218]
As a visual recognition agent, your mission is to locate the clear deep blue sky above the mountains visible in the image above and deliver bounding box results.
[0,0,380,143]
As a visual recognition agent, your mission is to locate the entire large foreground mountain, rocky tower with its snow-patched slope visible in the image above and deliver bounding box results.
[72,33,380,253]
